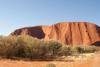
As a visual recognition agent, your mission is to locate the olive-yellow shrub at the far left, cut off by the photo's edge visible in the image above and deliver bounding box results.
[0,36,16,56]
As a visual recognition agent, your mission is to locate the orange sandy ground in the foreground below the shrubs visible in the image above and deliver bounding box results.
[0,54,100,67]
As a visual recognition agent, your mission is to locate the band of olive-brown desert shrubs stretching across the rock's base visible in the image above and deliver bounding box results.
[0,35,99,60]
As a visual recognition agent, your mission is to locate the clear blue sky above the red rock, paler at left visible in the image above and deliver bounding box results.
[0,0,100,35]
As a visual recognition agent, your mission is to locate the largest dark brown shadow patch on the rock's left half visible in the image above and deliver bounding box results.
[28,26,45,39]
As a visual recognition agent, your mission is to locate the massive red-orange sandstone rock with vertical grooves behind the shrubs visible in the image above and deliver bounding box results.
[11,22,100,45]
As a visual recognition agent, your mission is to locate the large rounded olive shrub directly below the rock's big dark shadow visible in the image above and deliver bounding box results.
[17,36,45,58]
